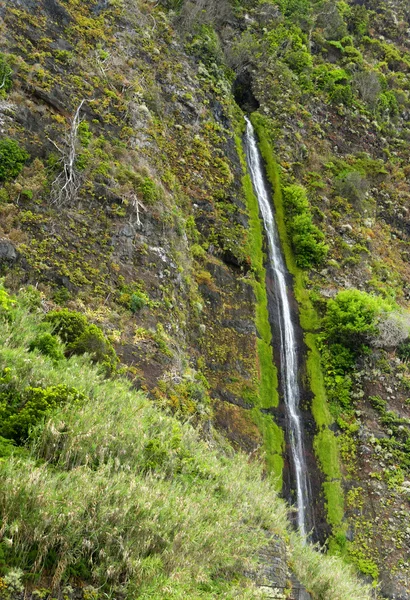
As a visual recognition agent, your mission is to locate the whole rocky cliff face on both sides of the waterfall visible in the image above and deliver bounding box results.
[0,0,410,599]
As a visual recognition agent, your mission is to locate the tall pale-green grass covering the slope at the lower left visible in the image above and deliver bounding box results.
[0,284,370,600]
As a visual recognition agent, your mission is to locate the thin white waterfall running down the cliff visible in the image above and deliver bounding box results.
[245,117,309,537]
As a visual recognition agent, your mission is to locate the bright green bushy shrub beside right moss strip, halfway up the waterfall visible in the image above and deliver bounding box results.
[283,185,328,269]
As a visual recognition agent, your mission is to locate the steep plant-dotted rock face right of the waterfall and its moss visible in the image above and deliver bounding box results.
[224,1,410,598]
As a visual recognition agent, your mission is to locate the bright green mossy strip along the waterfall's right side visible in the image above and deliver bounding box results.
[252,113,344,546]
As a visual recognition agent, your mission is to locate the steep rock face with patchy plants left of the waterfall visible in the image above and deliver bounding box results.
[0,0,261,450]
